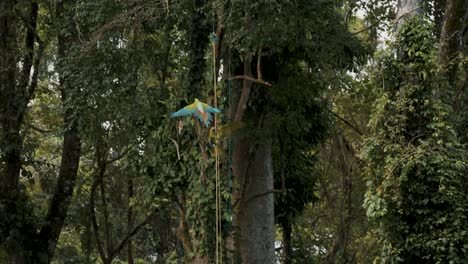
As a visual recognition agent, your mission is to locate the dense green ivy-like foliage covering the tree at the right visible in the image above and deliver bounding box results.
[362,17,468,263]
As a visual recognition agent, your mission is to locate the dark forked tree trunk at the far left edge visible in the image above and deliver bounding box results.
[0,0,40,264]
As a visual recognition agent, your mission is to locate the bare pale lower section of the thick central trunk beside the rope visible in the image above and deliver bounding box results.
[233,137,275,264]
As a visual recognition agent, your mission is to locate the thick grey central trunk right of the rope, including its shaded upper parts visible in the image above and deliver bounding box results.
[229,56,275,264]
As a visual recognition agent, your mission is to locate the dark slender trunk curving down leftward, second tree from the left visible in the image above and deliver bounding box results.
[33,1,81,263]
